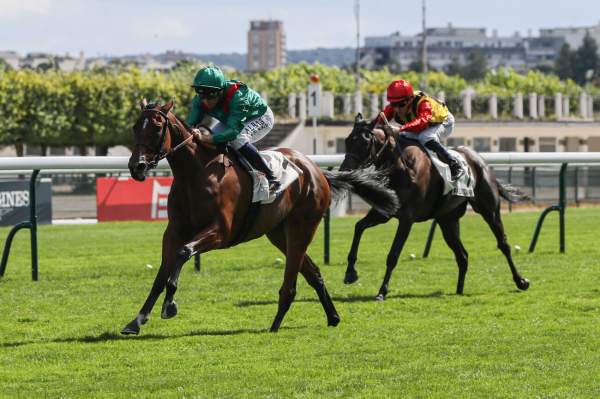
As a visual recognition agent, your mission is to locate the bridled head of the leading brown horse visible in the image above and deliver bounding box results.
[128,99,173,181]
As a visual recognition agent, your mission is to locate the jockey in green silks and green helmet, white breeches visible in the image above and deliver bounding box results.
[186,66,279,191]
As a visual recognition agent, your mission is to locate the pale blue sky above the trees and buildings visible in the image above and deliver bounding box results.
[0,0,600,57]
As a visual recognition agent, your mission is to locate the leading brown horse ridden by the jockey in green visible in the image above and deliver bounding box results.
[122,100,398,334]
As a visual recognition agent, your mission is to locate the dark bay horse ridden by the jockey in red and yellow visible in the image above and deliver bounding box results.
[340,114,529,300]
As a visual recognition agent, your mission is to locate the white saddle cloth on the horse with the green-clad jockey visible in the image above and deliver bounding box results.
[249,150,302,204]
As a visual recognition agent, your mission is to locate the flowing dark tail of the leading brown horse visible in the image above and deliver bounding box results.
[323,167,399,216]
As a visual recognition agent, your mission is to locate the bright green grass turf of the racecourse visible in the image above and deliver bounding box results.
[0,209,600,398]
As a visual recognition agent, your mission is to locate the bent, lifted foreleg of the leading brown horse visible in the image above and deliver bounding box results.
[160,227,222,319]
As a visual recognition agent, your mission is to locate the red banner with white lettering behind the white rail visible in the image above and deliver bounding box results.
[96,177,173,222]
